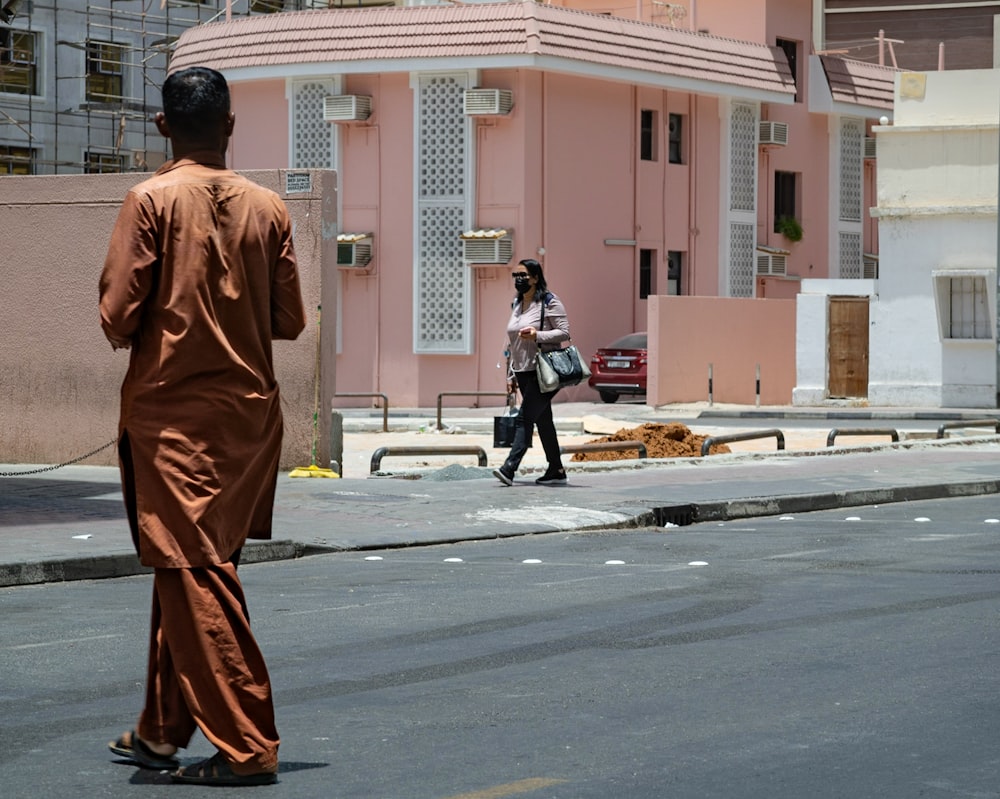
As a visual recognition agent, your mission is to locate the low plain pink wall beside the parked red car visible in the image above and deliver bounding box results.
[647,296,795,405]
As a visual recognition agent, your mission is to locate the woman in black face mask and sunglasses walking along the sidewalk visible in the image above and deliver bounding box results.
[493,258,569,485]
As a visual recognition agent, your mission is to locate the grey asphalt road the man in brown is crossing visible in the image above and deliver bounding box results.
[0,497,1000,799]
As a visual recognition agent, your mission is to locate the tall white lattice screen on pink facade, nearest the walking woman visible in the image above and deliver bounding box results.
[414,75,471,353]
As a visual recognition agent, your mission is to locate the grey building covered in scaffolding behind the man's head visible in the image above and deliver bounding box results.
[0,0,392,175]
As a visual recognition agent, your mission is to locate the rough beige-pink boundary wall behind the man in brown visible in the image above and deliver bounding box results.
[0,170,337,468]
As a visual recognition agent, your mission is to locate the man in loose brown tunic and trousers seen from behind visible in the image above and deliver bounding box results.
[100,67,305,784]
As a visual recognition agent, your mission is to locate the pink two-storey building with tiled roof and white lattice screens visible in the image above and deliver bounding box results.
[171,0,893,407]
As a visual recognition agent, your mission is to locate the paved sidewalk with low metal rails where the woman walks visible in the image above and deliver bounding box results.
[0,403,1000,586]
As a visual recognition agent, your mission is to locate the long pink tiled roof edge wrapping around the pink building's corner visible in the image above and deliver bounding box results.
[170,0,795,100]
